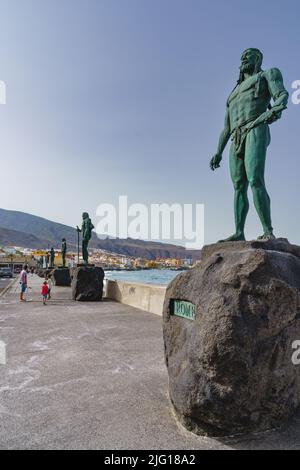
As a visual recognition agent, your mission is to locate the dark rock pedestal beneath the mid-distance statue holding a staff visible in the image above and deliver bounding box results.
[72,265,104,302]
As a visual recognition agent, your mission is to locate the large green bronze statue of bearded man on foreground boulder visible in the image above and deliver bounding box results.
[210,49,289,241]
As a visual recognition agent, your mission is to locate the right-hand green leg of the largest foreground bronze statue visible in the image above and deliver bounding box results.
[245,124,275,240]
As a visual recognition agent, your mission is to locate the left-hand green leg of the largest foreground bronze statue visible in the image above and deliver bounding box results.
[220,143,249,242]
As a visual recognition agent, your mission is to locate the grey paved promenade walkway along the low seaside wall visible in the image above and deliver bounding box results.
[0,276,300,450]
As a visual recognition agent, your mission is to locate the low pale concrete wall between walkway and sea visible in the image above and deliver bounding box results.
[106,280,166,315]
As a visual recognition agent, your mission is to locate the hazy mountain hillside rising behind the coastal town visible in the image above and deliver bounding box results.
[0,209,200,259]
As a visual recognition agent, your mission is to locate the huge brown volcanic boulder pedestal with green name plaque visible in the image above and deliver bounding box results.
[163,239,300,436]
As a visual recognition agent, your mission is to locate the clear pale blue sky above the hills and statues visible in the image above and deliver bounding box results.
[0,0,300,243]
